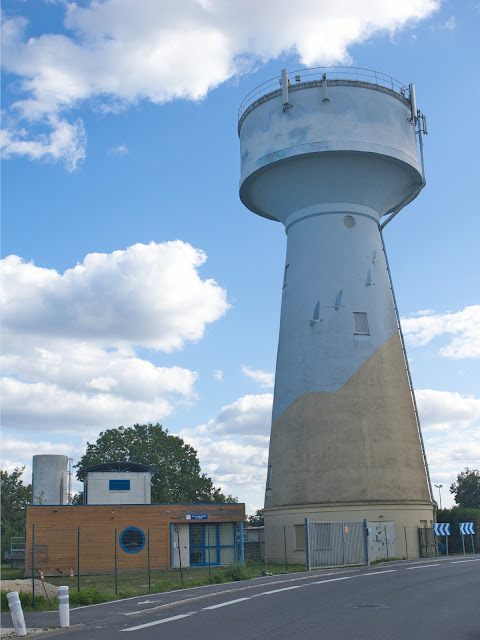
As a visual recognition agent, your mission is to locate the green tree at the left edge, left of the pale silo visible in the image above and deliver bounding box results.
[0,467,32,558]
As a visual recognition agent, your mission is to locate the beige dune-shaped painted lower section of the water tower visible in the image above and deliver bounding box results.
[265,334,433,560]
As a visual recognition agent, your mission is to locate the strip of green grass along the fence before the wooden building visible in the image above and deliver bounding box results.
[2,562,306,611]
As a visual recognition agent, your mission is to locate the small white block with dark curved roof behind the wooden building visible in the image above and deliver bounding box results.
[78,462,157,505]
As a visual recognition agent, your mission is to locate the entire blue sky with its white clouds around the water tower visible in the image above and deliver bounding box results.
[2,0,480,513]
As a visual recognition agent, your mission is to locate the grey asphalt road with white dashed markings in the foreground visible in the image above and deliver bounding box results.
[15,557,480,640]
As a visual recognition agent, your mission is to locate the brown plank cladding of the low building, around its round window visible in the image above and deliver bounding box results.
[25,503,245,576]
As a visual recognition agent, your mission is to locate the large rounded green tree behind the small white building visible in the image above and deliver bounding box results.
[75,424,236,503]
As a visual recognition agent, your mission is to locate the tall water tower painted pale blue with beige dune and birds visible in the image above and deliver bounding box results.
[238,67,433,559]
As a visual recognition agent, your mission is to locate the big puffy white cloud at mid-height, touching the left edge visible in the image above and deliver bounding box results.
[1,240,229,352]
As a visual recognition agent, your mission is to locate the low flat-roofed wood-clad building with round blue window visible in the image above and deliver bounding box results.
[25,504,245,581]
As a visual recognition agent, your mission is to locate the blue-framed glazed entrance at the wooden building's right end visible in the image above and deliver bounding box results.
[189,522,237,567]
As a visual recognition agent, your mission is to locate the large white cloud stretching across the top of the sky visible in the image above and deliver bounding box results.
[3,0,440,166]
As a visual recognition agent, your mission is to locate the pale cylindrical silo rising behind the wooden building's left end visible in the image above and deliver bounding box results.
[32,455,71,505]
